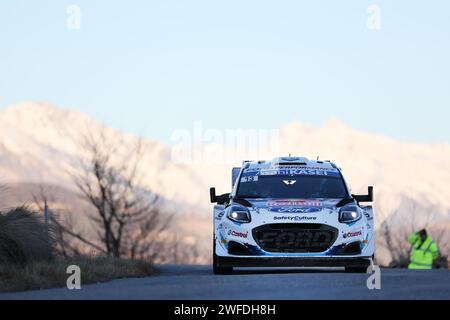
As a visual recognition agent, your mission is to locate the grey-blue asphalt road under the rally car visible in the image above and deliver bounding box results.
[0,265,450,300]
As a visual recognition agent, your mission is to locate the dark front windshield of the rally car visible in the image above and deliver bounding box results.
[237,175,348,199]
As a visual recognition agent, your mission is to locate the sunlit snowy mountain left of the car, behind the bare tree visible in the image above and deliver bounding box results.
[0,103,207,212]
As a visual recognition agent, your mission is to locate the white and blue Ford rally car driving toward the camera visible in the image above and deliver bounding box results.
[210,157,375,274]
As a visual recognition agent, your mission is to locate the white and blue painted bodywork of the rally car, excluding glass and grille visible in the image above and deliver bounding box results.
[214,158,375,259]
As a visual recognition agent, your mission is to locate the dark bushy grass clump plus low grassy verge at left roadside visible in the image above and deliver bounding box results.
[0,207,155,292]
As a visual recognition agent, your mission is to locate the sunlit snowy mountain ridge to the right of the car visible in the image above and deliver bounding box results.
[281,120,450,224]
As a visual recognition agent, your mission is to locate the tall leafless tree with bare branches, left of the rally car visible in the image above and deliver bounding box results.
[51,129,171,258]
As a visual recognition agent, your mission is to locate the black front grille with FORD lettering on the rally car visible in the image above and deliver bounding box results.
[253,223,338,253]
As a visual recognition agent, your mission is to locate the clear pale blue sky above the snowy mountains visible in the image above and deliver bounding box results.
[0,0,450,143]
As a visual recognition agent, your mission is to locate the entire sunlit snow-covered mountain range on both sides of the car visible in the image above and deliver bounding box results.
[0,103,450,228]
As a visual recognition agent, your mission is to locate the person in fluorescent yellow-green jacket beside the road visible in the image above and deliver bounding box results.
[408,229,439,269]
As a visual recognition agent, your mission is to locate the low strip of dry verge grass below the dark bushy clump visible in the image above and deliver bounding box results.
[0,257,156,292]
